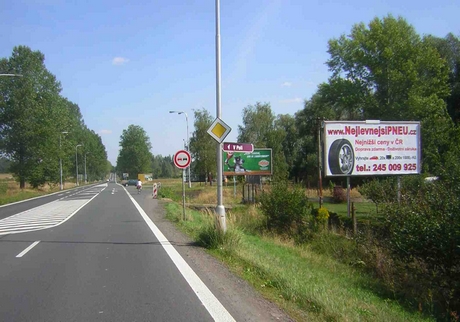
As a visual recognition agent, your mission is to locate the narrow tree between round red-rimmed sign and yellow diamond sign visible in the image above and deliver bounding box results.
[190,108,217,182]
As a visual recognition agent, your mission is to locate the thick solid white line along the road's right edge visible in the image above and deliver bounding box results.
[123,188,235,322]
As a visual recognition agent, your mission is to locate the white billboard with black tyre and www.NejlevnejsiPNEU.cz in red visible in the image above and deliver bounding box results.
[324,121,421,176]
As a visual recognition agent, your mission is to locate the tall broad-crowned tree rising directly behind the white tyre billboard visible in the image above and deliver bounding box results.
[327,15,454,172]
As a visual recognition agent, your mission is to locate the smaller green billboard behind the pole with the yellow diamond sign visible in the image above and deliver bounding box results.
[222,149,273,176]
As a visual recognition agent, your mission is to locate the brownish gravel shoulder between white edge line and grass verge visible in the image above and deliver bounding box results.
[142,197,293,321]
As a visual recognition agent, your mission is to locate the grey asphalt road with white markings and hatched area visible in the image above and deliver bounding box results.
[0,183,233,321]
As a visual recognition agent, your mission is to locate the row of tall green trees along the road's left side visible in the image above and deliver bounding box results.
[0,46,111,189]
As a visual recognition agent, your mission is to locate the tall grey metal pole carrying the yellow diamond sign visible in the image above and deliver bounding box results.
[216,0,227,233]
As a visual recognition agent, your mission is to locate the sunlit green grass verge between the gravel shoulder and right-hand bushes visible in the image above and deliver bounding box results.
[165,202,429,321]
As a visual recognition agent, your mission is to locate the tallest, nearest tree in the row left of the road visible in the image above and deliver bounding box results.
[0,46,63,189]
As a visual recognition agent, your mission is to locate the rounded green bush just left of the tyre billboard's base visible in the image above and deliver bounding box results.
[260,183,314,242]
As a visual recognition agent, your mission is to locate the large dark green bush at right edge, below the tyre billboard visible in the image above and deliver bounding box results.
[384,177,460,317]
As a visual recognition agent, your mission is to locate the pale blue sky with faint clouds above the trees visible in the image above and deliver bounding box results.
[0,0,460,165]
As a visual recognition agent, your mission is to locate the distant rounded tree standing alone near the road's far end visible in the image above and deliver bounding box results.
[117,124,152,178]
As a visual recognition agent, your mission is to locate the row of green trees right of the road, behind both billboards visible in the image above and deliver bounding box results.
[117,15,460,185]
